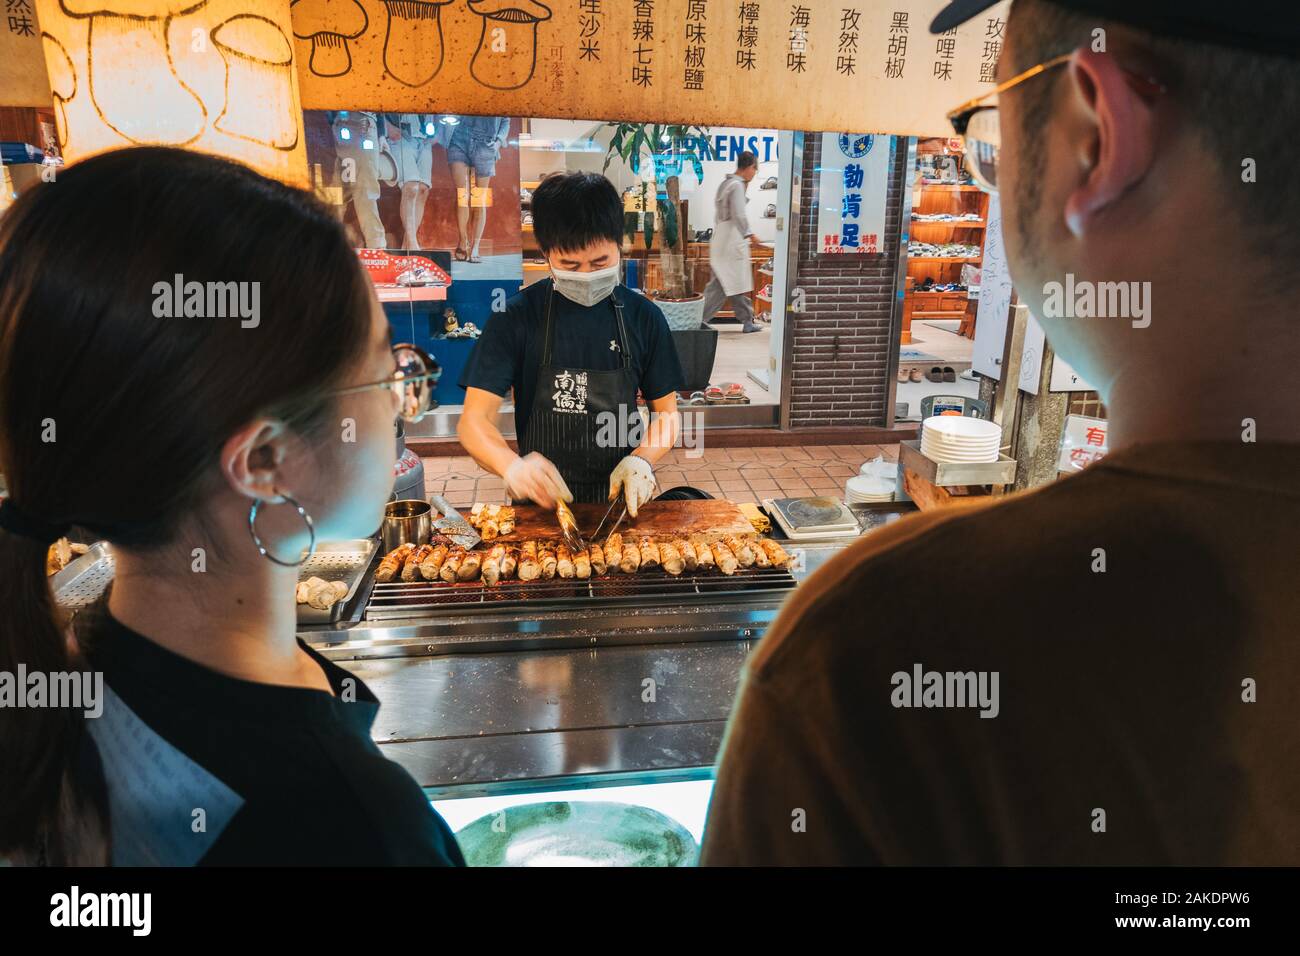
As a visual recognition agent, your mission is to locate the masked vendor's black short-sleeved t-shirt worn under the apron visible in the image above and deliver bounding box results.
[460,278,685,437]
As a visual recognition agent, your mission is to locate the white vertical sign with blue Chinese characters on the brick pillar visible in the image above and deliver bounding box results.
[816,133,893,255]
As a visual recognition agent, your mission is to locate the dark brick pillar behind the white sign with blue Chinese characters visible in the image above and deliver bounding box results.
[787,133,907,428]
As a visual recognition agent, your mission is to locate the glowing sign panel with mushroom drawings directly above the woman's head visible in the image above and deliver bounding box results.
[36,0,307,185]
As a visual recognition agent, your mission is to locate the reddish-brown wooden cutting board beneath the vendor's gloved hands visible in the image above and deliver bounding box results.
[488,498,754,544]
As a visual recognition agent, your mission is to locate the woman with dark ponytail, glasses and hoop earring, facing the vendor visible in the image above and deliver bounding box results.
[0,148,462,865]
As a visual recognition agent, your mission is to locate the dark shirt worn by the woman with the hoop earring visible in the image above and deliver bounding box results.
[86,611,464,866]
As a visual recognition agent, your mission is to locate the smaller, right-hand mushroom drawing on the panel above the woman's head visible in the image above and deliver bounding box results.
[212,13,300,151]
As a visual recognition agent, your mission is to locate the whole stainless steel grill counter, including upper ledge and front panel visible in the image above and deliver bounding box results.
[303,509,915,796]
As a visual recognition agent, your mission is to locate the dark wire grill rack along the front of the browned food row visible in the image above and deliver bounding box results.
[365,567,794,620]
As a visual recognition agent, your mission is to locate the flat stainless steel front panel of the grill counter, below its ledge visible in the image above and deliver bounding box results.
[345,640,753,796]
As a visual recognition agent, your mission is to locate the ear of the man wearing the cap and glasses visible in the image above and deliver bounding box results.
[1065,47,1156,237]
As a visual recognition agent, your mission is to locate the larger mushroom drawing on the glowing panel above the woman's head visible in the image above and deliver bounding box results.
[59,0,208,146]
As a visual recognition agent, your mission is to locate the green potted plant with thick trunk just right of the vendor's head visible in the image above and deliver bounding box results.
[603,122,714,299]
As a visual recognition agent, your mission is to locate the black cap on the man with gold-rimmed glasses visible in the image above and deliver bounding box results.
[930,0,1300,57]
